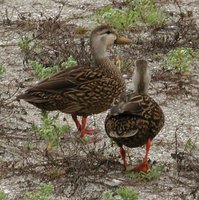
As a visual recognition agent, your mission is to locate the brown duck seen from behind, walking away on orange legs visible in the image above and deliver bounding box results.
[105,60,165,173]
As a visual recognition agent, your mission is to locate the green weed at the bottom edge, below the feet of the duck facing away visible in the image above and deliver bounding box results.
[102,187,138,200]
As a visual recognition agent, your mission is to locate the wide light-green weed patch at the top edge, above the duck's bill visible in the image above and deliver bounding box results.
[91,0,166,30]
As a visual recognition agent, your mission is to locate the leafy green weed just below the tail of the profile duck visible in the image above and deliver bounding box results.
[32,111,70,149]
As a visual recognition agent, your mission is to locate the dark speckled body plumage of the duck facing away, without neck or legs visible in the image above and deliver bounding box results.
[105,94,164,145]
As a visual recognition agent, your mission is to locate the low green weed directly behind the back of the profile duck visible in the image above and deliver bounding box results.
[31,56,77,79]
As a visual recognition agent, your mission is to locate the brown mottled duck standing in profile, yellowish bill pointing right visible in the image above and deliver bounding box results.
[17,25,131,138]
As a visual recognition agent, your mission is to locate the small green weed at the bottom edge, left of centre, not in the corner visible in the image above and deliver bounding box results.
[25,183,54,200]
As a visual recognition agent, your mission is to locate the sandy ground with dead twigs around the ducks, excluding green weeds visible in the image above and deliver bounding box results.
[0,0,199,200]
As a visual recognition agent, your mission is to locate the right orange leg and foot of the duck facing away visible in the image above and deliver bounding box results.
[131,139,151,173]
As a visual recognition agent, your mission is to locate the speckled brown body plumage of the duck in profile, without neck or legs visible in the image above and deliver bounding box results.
[19,60,125,116]
